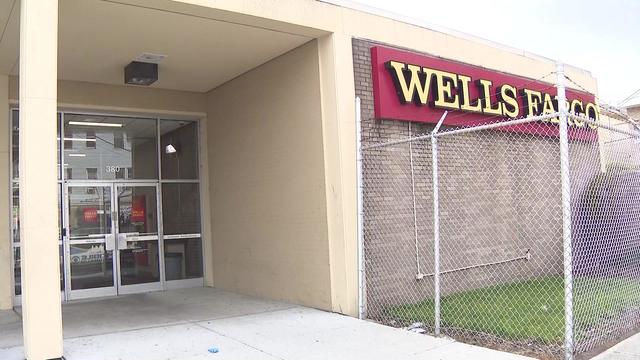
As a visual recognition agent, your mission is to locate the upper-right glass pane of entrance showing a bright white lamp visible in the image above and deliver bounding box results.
[160,120,198,179]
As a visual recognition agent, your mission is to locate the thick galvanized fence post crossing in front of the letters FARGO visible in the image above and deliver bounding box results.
[557,63,574,360]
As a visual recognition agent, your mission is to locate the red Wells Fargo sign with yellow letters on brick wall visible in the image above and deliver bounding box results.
[371,46,600,139]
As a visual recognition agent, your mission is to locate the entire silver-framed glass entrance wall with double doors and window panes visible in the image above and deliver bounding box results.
[12,109,203,300]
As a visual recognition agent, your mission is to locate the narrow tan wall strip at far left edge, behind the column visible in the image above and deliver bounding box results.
[0,75,13,310]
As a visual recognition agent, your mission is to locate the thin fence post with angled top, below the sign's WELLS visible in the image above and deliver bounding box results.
[430,111,448,336]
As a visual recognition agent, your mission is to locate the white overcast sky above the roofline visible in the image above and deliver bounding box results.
[351,0,640,105]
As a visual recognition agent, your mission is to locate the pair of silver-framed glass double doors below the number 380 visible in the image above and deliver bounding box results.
[65,183,163,299]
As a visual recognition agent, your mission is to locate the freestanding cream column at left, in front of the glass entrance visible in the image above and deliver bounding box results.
[20,0,62,360]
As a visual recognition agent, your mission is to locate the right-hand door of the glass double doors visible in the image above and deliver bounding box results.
[115,183,163,294]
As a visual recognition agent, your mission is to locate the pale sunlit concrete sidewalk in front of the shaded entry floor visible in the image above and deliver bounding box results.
[0,307,526,360]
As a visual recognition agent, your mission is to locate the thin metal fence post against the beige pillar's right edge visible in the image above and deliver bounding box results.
[356,97,365,319]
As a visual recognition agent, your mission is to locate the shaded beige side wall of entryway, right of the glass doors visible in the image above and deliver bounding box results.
[207,41,331,310]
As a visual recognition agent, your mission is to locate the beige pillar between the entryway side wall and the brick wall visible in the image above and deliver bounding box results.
[318,33,359,316]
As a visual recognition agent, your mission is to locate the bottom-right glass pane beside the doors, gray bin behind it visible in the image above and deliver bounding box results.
[164,238,202,281]
